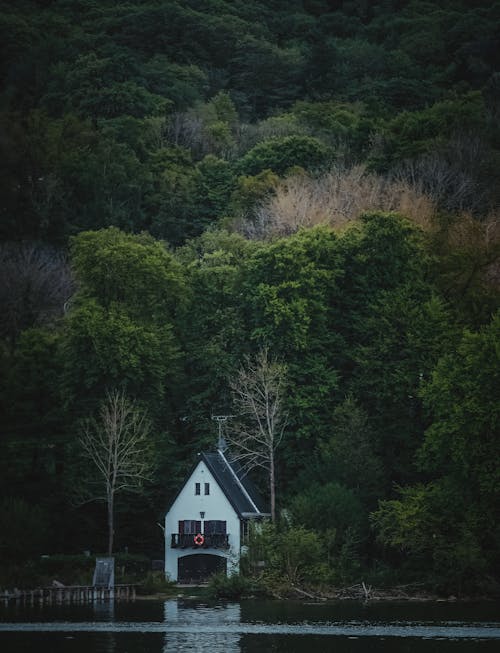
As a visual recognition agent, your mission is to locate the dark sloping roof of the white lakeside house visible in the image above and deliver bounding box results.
[200,451,269,517]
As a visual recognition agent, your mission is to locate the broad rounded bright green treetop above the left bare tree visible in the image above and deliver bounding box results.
[64,228,184,414]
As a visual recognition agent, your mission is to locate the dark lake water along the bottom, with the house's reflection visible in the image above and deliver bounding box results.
[0,598,500,653]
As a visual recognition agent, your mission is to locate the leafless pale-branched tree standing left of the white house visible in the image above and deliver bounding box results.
[80,390,153,555]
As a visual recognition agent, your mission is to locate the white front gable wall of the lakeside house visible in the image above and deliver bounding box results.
[165,460,240,581]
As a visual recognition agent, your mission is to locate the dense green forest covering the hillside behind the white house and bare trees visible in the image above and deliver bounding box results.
[0,0,500,592]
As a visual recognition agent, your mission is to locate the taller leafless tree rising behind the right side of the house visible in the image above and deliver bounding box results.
[226,348,287,521]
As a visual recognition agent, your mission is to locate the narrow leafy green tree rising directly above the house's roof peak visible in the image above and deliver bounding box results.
[177,231,255,447]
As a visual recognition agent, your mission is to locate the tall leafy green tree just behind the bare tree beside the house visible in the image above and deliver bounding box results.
[243,227,342,475]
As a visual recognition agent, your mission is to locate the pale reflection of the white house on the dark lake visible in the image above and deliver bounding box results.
[163,599,241,653]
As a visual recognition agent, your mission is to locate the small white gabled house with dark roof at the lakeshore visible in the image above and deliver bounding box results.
[165,449,269,583]
